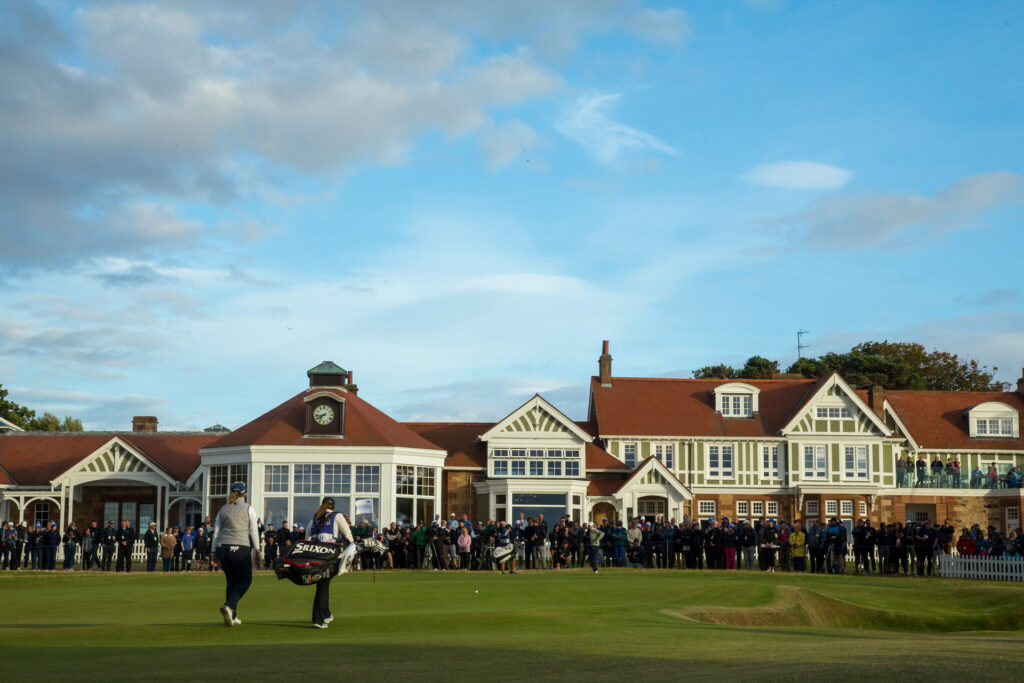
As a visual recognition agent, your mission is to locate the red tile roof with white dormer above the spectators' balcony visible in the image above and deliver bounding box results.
[886,391,1024,451]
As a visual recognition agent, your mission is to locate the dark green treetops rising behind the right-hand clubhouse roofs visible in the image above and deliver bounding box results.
[693,341,1010,391]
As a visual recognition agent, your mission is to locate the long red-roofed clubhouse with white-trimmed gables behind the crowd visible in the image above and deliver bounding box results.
[0,342,1024,529]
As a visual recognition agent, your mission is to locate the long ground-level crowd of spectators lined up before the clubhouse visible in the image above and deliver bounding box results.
[0,515,1024,575]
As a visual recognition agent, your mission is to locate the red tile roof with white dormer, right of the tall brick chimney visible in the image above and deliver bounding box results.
[591,377,825,436]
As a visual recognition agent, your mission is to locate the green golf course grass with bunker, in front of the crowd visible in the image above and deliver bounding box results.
[0,569,1024,681]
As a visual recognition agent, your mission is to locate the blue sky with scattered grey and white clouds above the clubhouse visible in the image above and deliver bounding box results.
[0,0,1024,429]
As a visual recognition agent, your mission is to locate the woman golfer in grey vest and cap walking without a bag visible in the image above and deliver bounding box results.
[213,481,259,626]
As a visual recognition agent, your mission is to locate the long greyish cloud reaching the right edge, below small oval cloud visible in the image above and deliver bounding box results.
[784,171,1024,248]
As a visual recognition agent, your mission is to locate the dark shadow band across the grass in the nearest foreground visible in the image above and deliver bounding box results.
[4,643,1019,682]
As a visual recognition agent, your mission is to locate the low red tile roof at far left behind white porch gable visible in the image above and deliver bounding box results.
[0,432,217,486]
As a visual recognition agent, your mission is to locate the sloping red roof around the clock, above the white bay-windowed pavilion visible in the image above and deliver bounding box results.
[207,387,437,451]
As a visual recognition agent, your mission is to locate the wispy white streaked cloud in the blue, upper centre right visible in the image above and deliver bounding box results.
[555,93,679,164]
